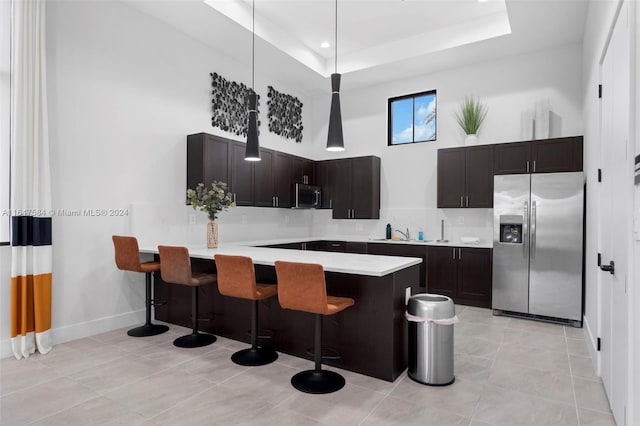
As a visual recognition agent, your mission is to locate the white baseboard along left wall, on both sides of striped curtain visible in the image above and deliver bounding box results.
[0,309,145,358]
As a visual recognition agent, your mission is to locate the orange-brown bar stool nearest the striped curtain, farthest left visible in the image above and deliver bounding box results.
[111,235,169,337]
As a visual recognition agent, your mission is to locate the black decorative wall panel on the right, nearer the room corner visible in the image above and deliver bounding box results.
[267,86,303,143]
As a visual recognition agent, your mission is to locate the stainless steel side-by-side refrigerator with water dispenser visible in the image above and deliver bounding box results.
[492,172,584,326]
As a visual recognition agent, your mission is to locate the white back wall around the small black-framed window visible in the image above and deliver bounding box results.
[313,44,583,240]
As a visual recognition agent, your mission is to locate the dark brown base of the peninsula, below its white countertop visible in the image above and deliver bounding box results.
[154,256,419,381]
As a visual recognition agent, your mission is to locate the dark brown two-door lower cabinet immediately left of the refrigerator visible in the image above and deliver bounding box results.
[427,246,492,308]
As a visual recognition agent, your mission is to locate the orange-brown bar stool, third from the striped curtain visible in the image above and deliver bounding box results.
[214,254,278,367]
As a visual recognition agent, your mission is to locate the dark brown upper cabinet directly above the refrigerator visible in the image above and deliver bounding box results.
[494,136,583,175]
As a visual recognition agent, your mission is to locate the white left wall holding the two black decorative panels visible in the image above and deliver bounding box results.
[0,1,312,355]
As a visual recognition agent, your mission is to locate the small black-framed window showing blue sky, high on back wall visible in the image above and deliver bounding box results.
[387,90,436,146]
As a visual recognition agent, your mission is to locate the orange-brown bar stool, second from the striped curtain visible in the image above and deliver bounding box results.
[158,246,216,348]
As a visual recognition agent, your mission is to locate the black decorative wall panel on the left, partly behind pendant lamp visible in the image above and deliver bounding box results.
[211,73,260,136]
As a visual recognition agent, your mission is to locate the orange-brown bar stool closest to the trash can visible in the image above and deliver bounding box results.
[275,261,355,394]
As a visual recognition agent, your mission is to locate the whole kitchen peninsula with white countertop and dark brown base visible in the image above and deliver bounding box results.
[141,244,424,381]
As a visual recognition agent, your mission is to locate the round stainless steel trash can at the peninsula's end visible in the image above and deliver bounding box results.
[406,293,458,386]
